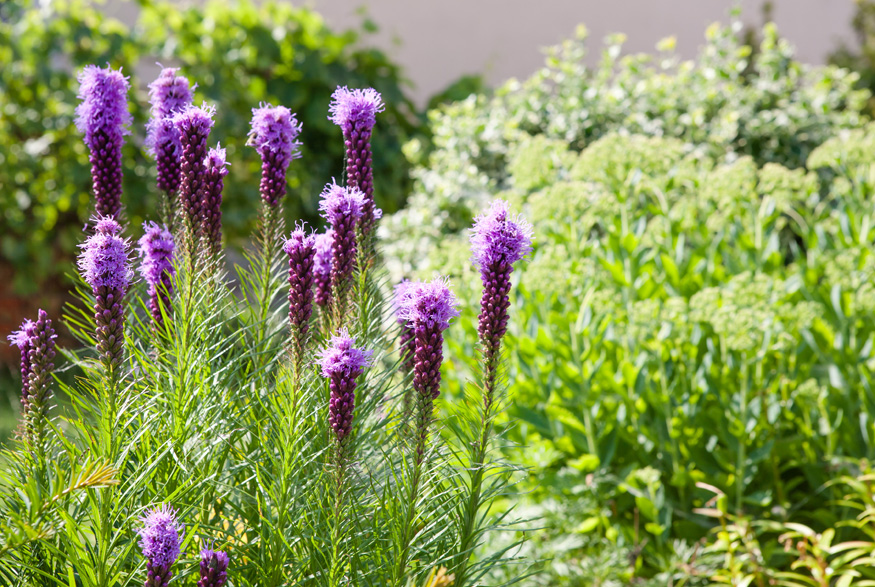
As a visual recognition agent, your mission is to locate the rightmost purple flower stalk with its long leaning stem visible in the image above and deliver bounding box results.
[454,200,532,585]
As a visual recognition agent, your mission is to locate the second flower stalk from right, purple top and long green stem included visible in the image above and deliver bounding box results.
[393,278,459,586]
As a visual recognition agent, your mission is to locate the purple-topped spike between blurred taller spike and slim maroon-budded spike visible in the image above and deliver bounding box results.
[172,104,216,243]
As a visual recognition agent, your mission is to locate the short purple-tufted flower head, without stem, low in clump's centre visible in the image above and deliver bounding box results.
[319,329,373,443]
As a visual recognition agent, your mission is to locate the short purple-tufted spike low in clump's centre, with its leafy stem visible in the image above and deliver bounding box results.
[319,330,372,587]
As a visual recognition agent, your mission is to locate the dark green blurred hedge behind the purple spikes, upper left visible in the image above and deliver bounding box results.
[0,0,416,293]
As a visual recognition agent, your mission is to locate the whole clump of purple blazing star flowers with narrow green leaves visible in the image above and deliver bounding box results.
[0,68,529,587]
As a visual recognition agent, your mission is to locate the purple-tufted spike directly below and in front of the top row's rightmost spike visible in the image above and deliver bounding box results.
[319,182,364,328]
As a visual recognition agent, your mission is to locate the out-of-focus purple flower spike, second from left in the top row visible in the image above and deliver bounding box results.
[146,67,192,196]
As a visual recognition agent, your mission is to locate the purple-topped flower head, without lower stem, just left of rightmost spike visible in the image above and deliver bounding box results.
[396,277,459,460]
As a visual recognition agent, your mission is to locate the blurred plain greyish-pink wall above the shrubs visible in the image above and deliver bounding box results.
[106,0,856,105]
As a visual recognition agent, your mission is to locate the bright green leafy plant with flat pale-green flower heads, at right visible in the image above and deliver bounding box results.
[406,113,875,585]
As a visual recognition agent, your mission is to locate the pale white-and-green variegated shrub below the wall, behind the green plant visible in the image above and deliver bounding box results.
[385,23,868,274]
